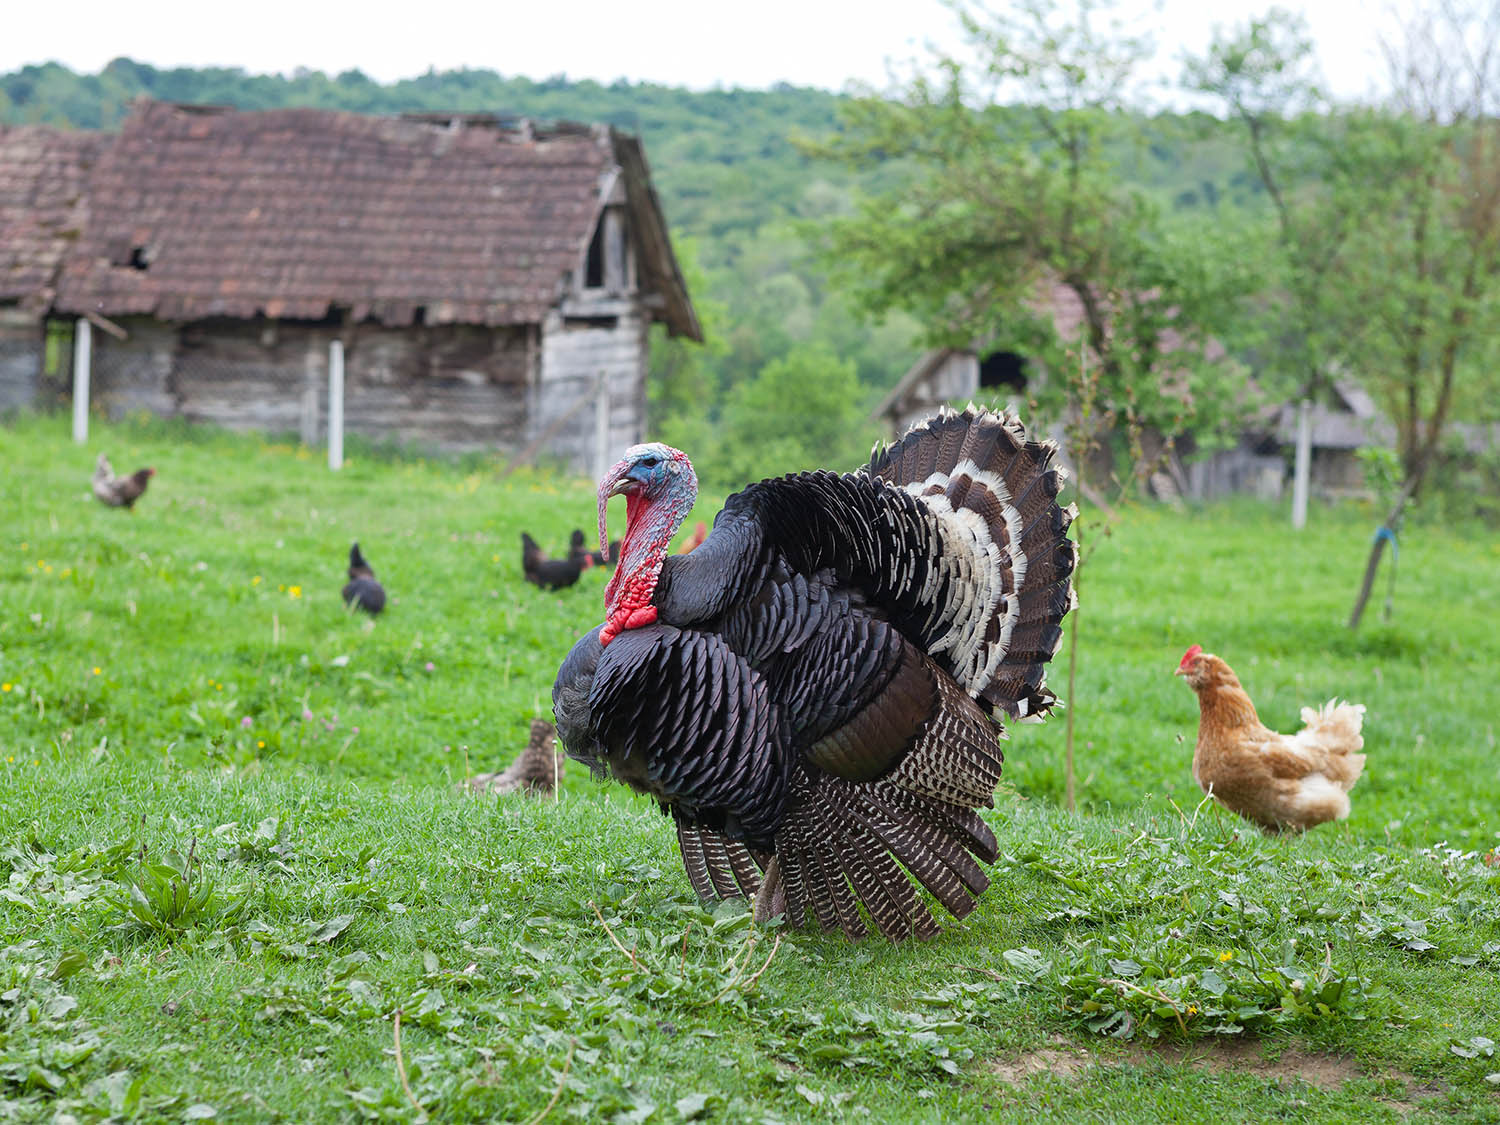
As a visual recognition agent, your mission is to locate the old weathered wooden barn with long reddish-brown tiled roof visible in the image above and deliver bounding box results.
[0,102,701,470]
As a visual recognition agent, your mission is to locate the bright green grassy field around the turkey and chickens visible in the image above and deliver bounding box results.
[0,419,1500,1122]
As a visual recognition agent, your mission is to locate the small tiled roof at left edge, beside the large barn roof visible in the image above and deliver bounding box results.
[0,125,113,312]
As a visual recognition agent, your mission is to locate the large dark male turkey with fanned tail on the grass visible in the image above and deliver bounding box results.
[552,407,1076,939]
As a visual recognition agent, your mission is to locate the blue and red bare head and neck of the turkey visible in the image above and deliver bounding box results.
[599,441,698,645]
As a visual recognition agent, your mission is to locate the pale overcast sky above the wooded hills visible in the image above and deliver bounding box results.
[0,0,1383,103]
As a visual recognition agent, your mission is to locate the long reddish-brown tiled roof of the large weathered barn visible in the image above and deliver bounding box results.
[54,102,702,339]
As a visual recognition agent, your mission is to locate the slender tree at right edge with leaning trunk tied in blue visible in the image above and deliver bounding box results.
[1349,0,1500,629]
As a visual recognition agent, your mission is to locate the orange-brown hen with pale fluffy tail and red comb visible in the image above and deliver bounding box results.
[1176,645,1365,833]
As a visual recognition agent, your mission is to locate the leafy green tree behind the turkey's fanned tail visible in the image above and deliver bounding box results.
[815,0,1236,459]
